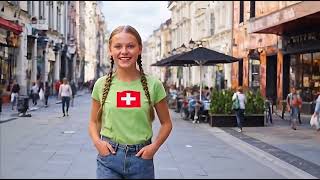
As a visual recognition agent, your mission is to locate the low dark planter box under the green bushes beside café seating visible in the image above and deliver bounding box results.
[209,114,264,127]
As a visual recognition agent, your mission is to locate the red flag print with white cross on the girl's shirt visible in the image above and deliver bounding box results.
[117,91,141,108]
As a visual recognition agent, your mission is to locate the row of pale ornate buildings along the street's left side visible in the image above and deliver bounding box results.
[0,1,107,103]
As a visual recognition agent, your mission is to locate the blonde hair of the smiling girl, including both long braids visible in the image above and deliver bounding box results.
[97,25,155,129]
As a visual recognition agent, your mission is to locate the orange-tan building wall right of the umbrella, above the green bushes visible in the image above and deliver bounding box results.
[231,1,279,94]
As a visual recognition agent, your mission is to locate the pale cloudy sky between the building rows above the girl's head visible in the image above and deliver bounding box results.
[102,1,171,41]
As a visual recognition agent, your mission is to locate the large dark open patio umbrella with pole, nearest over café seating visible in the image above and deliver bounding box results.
[165,47,239,98]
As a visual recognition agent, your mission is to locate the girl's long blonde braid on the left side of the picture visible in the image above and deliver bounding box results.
[97,56,114,130]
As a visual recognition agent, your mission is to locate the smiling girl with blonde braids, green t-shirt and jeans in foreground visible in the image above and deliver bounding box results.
[89,26,172,179]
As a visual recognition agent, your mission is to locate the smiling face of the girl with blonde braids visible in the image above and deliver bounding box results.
[109,32,142,69]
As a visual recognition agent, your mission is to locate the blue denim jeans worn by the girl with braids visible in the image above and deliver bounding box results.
[97,137,154,179]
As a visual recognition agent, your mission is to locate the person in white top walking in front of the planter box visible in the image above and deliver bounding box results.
[232,86,247,132]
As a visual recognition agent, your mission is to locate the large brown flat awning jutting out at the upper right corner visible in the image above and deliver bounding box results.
[248,1,320,36]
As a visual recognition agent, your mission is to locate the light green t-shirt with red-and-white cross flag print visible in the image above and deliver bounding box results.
[92,76,166,144]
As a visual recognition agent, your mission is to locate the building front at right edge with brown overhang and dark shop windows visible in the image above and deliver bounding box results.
[248,1,320,114]
